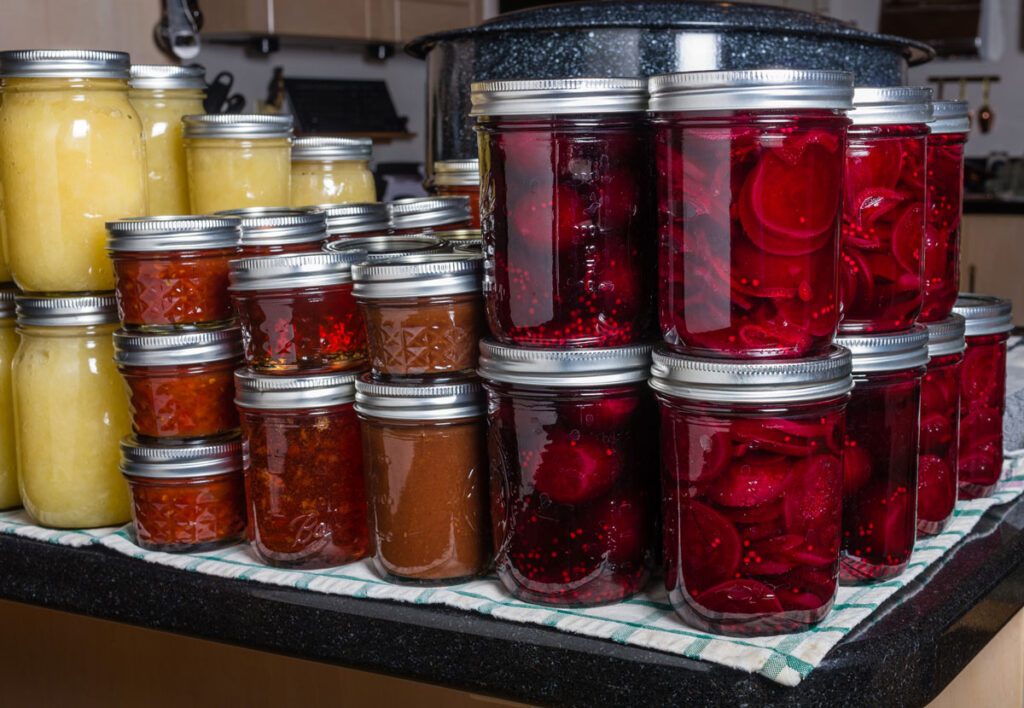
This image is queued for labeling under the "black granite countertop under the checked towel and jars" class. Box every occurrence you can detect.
[0,497,1024,706]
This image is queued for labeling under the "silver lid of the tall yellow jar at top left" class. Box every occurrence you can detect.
[0,49,131,79]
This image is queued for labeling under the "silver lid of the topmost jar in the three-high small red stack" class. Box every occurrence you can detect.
[106,216,242,253]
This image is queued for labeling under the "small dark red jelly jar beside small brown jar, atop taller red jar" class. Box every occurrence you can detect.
[230,250,367,374]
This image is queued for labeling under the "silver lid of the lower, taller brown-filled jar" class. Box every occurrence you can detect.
[355,373,487,421]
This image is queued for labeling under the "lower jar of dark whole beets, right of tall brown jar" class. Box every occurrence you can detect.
[479,340,657,607]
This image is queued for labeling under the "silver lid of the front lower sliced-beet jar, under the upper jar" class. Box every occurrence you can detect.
[650,344,853,404]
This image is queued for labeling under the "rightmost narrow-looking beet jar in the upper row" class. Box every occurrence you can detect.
[919,100,971,322]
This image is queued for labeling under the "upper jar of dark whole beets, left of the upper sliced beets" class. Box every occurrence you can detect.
[472,79,654,348]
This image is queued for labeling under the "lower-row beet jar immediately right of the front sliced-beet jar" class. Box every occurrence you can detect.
[837,325,928,585]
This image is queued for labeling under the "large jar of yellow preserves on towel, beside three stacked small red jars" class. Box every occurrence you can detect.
[12,295,131,529]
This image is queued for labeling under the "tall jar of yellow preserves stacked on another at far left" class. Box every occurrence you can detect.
[0,49,146,293]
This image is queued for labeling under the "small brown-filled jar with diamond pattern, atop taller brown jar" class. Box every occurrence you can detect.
[352,253,485,376]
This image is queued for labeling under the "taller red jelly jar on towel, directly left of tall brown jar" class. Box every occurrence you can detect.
[234,369,369,569]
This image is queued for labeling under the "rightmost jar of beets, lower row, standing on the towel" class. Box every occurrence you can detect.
[953,293,1013,499]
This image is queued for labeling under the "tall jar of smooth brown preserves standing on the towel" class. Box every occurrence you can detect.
[355,374,490,585]
